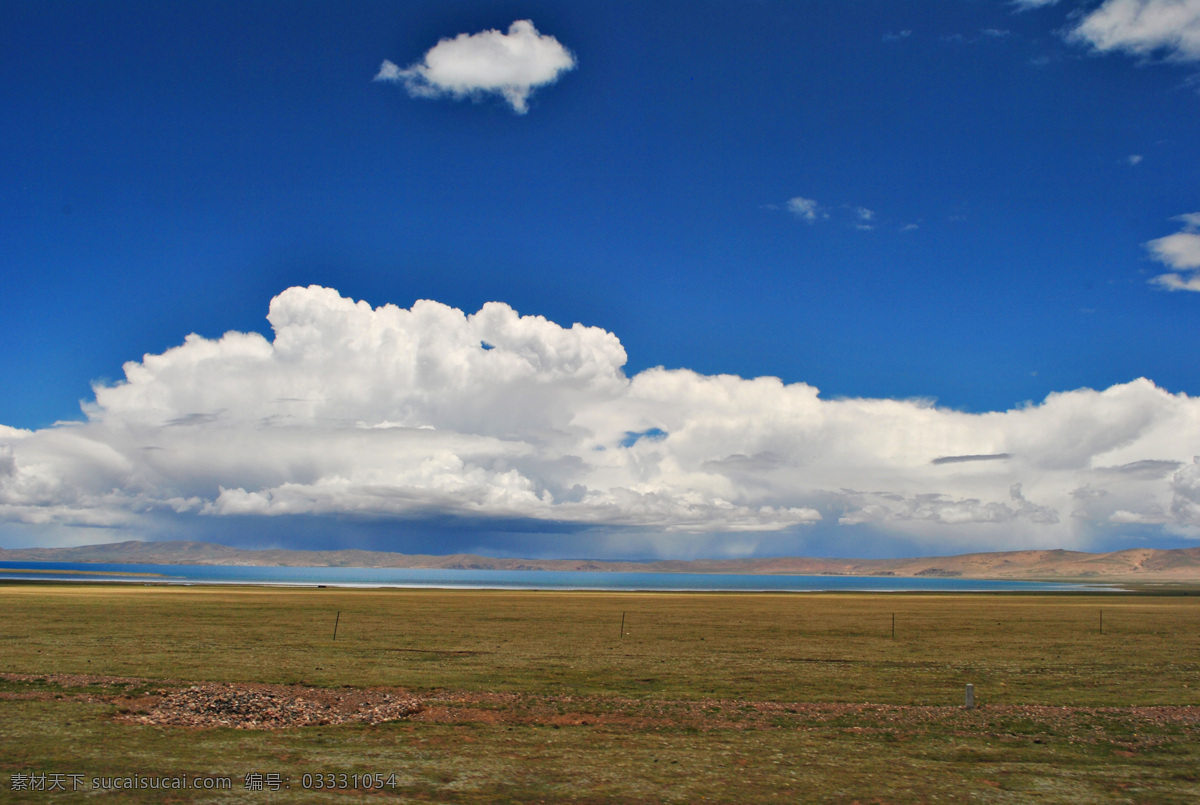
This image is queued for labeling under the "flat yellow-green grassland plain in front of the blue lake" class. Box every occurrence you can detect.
[0,582,1200,803]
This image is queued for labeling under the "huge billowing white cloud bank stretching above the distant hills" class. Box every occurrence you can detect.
[0,287,1200,552]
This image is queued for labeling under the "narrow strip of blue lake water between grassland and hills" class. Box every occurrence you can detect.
[0,561,1115,593]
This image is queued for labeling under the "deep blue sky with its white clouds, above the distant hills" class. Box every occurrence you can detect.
[0,0,1200,555]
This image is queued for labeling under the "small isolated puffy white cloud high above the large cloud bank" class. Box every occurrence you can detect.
[374,19,576,114]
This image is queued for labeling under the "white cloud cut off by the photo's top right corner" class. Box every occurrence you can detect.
[1068,0,1200,61]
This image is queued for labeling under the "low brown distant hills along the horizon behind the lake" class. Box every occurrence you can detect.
[0,541,1200,582]
